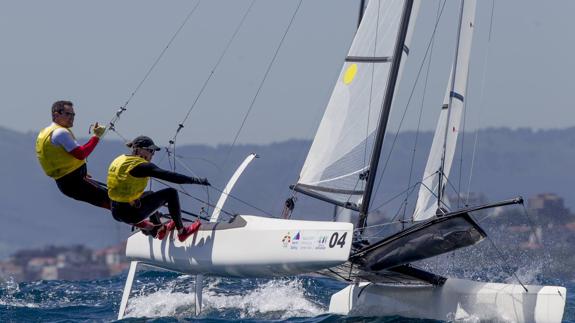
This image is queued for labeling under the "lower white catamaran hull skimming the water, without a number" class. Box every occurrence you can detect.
[329,279,566,322]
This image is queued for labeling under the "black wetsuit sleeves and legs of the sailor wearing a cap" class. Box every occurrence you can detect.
[112,163,203,229]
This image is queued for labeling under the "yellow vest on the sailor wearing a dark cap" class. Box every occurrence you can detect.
[108,155,149,202]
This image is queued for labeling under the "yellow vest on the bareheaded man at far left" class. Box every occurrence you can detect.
[36,124,86,179]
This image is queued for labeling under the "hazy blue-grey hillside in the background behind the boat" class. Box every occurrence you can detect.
[0,128,575,258]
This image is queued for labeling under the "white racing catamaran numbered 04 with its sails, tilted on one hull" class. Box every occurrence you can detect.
[118,0,566,322]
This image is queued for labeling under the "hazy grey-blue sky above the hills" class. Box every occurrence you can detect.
[0,0,575,145]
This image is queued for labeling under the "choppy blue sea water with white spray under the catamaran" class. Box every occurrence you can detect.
[0,271,575,322]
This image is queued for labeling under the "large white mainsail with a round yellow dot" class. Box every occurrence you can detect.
[297,0,419,208]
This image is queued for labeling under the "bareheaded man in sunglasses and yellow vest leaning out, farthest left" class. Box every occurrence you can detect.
[36,101,110,209]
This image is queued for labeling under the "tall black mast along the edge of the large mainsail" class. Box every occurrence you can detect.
[358,0,413,232]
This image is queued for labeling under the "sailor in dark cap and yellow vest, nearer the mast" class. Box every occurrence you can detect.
[108,136,210,242]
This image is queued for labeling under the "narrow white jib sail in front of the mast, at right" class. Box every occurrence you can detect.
[413,0,476,221]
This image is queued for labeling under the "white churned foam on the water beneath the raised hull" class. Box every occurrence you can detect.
[126,279,327,319]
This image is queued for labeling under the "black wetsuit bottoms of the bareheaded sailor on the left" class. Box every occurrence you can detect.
[56,164,110,209]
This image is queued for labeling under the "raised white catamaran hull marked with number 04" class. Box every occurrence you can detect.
[126,216,353,277]
